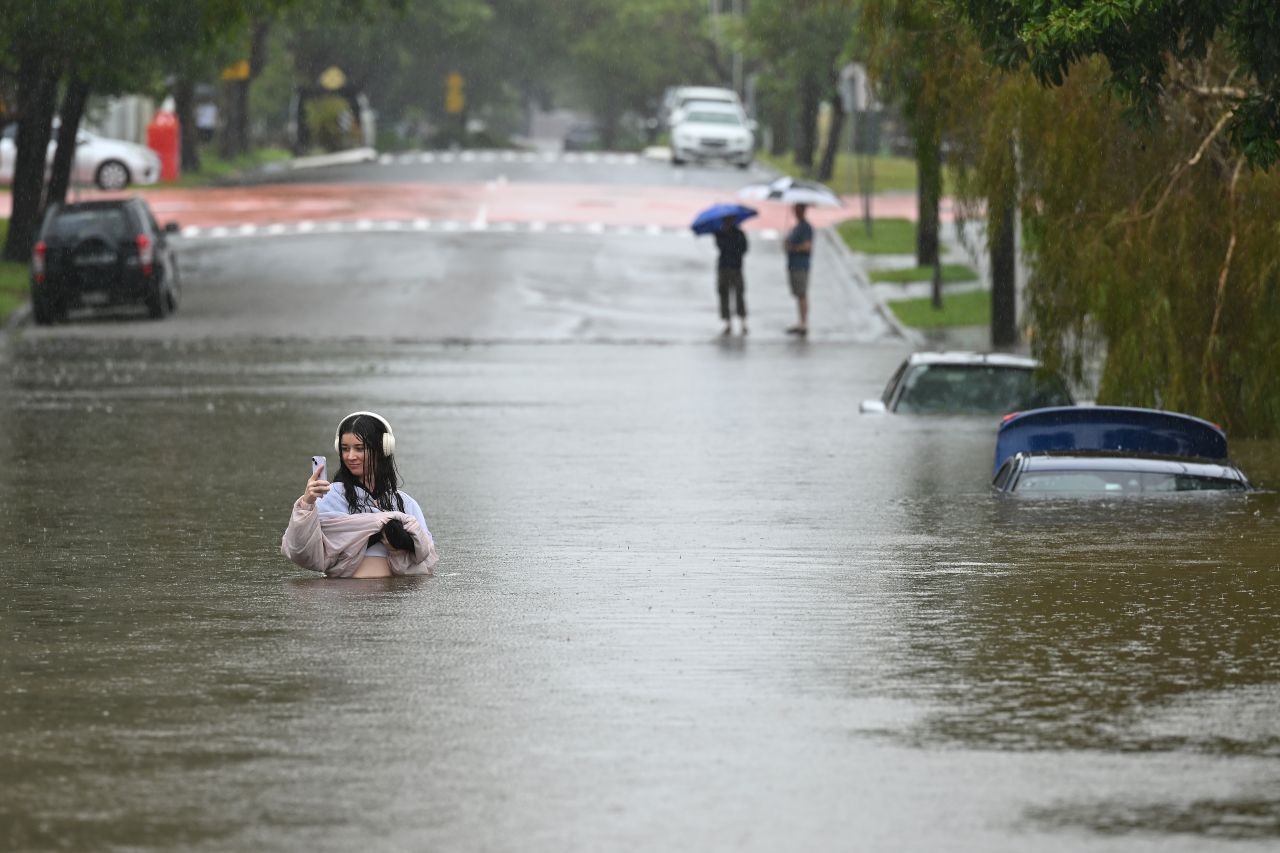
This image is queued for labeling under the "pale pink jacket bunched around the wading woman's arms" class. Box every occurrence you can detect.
[280,498,440,578]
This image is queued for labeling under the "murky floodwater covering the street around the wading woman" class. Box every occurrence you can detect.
[0,338,1280,850]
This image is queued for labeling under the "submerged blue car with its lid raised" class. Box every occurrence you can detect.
[992,406,1253,496]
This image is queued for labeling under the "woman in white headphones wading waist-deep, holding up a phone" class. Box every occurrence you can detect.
[280,411,439,578]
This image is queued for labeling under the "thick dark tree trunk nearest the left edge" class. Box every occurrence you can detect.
[4,54,58,264]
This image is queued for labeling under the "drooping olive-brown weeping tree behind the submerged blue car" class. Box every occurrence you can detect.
[942,3,1280,435]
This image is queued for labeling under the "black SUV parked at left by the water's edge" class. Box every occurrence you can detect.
[31,196,179,325]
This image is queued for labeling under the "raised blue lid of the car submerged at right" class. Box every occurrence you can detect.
[992,406,1226,474]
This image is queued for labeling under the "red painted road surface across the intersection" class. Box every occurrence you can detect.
[0,182,950,229]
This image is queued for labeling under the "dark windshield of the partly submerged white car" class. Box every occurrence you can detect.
[897,364,1071,415]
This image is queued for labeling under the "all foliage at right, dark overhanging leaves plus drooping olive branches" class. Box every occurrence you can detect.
[868,0,1280,437]
